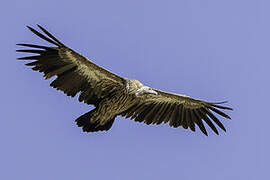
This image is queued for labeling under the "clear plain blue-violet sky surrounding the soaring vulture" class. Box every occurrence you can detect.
[0,0,270,180]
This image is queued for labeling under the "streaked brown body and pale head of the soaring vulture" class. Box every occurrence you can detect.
[77,79,155,131]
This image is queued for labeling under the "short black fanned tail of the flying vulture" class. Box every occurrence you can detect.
[75,110,115,132]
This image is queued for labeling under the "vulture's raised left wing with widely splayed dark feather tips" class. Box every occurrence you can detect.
[17,25,124,106]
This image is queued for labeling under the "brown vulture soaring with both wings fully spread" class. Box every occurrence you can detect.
[17,25,232,135]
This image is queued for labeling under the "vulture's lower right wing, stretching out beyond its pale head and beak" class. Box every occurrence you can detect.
[121,90,232,135]
